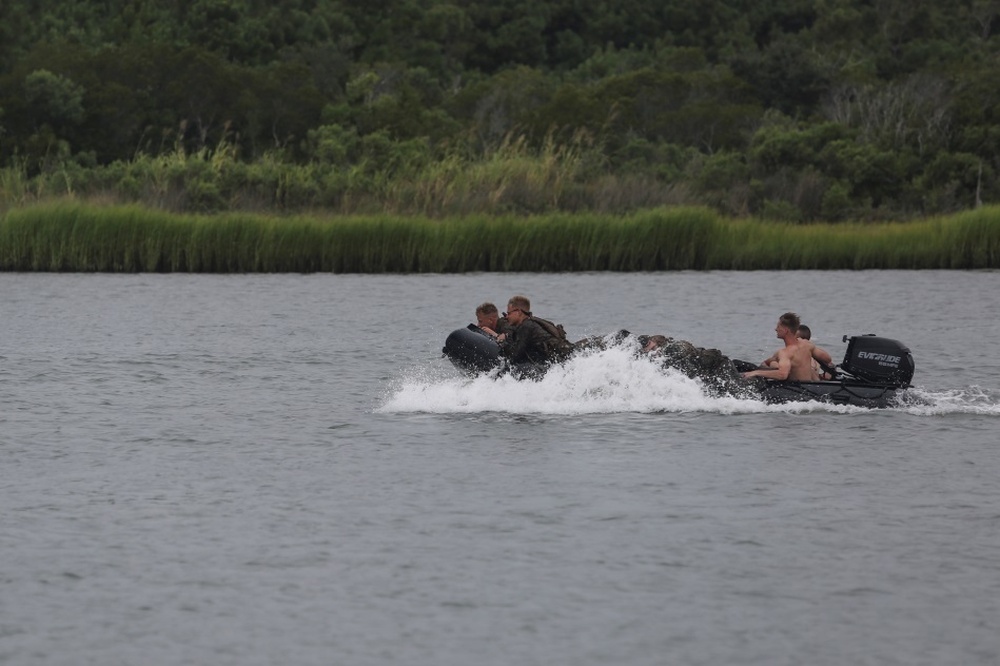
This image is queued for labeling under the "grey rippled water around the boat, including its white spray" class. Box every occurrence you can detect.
[0,272,1000,666]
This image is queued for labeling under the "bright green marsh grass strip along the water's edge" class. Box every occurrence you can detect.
[0,201,1000,273]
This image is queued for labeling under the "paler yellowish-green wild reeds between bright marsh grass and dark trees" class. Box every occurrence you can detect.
[0,135,693,218]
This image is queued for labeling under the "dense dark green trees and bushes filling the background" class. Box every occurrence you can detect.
[0,0,1000,220]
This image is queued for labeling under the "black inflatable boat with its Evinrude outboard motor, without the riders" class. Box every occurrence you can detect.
[441,324,915,408]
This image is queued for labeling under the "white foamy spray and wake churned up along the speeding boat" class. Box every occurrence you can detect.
[375,347,1000,416]
